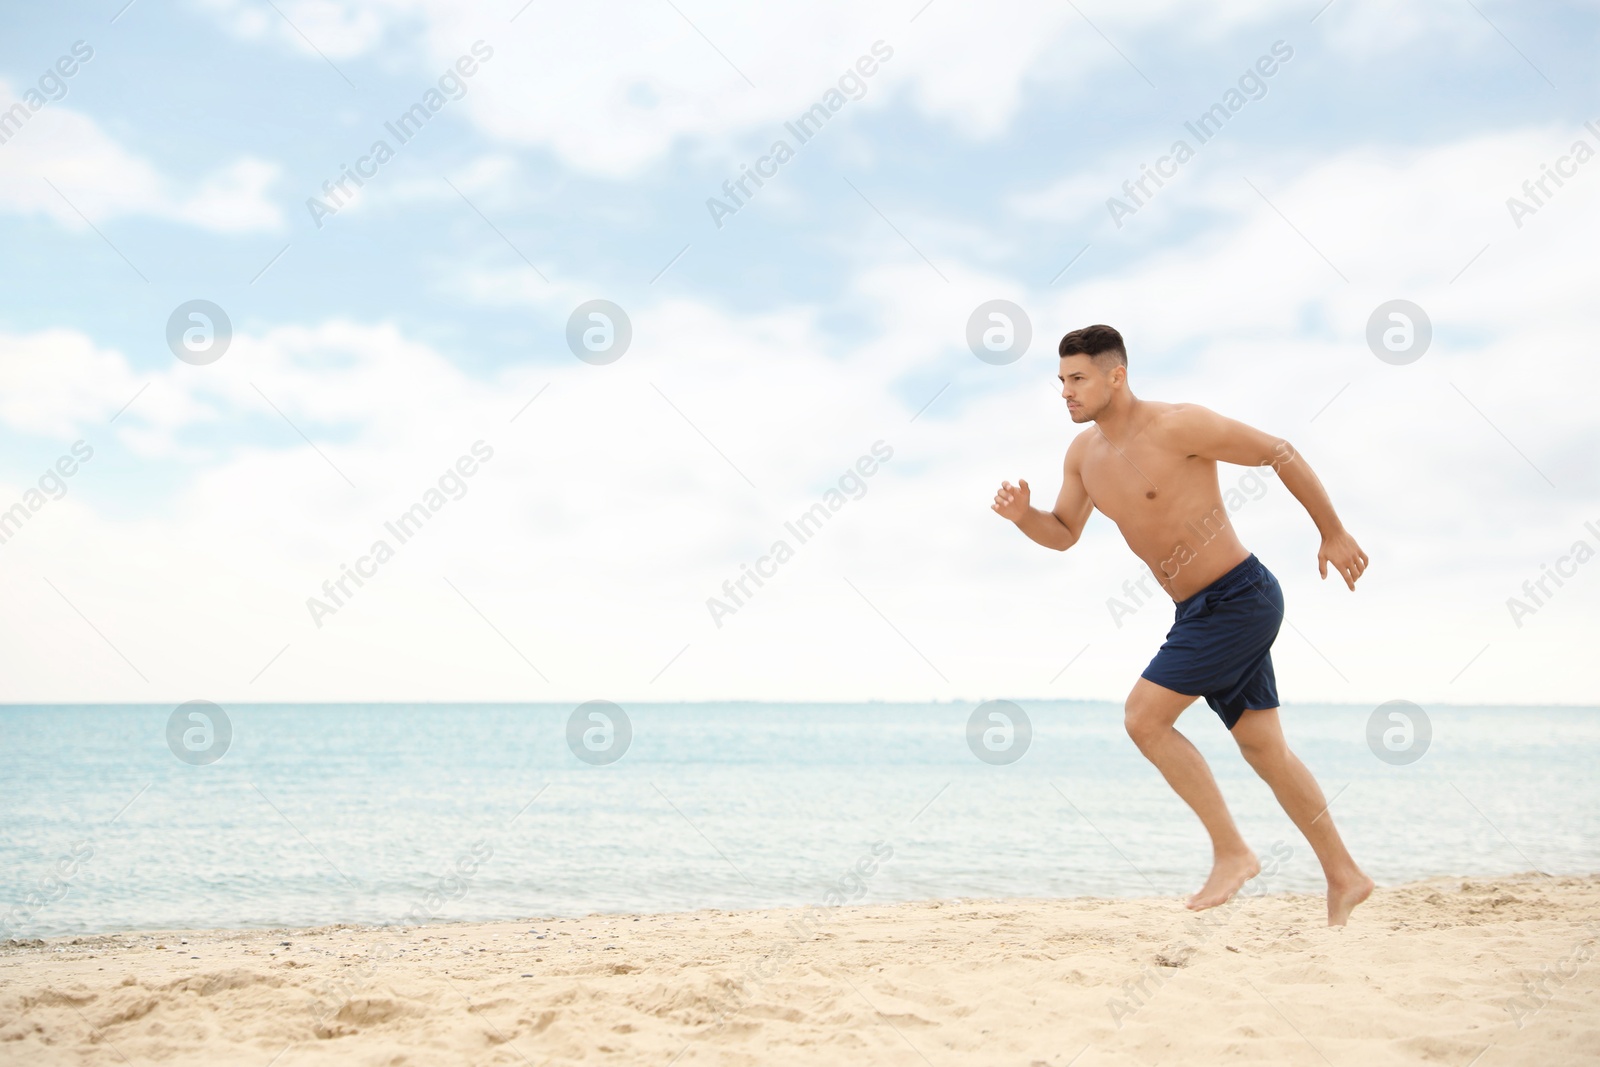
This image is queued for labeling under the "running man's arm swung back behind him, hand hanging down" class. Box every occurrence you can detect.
[1168,403,1366,590]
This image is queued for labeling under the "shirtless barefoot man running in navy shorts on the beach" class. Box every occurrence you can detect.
[994,326,1373,926]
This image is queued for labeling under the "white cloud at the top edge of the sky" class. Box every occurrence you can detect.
[190,0,1363,176]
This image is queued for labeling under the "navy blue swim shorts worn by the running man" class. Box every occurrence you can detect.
[1142,553,1283,729]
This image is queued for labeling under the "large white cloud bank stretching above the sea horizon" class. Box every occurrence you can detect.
[0,120,1600,702]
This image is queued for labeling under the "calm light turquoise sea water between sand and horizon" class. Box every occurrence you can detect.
[0,702,1600,937]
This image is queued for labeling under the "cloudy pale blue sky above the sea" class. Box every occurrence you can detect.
[0,0,1600,705]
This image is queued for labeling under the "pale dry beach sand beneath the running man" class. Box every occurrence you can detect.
[0,875,1600,1067]
